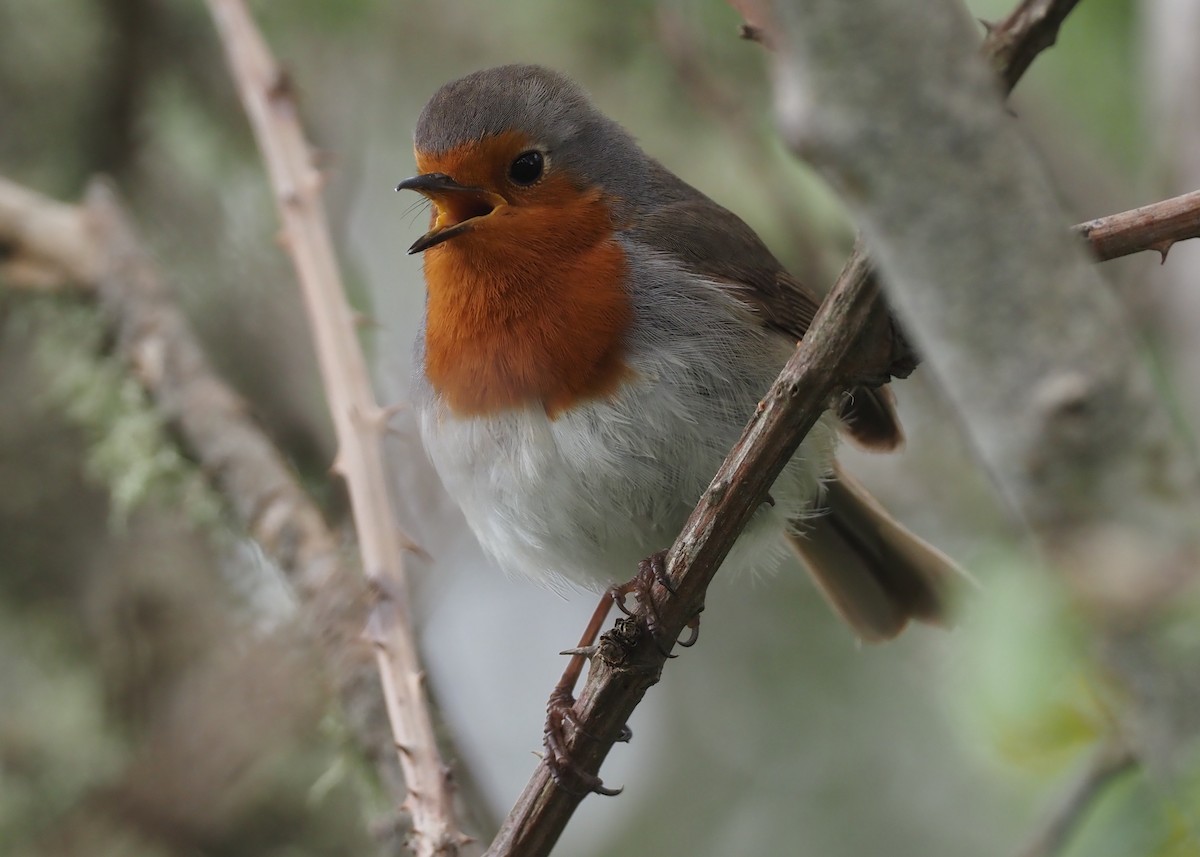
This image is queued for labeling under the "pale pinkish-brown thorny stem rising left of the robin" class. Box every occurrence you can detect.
[209,0,468,857]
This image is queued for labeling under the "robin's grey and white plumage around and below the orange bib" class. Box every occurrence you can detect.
[414,238,834,588]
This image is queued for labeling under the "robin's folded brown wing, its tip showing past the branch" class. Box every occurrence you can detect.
[629,177,904,450]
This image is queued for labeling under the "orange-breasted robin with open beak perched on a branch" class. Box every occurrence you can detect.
[396,65,958,791]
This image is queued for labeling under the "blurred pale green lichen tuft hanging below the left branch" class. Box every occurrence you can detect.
[26,300,222,528]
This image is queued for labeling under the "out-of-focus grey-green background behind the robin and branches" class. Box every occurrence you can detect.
[0,0,1200,857]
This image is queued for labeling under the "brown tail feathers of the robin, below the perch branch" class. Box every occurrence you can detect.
[790,469,962,642]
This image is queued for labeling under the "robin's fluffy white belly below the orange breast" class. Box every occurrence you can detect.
[418,336,834,589]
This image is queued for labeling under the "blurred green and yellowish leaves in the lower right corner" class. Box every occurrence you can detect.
[952,553,1200,857]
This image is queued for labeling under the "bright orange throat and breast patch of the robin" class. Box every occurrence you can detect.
[425,176,632,416]
